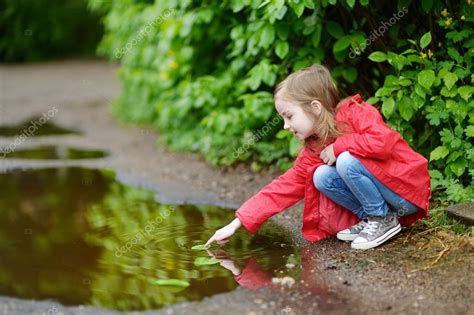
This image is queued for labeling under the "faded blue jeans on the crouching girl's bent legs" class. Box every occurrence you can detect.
[313,151,420,219]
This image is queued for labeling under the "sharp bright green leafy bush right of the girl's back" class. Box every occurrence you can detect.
[369,5,474,202]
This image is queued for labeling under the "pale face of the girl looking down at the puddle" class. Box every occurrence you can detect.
[275,95,314,140]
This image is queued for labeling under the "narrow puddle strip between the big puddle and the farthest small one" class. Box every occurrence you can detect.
[0,145,107,160]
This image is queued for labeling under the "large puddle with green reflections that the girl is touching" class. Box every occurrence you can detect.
[0,168,300,311]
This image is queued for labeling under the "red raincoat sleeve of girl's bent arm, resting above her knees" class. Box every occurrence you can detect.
[333,102,400,160]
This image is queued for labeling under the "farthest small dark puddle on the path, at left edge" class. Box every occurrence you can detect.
[0,117,79,137]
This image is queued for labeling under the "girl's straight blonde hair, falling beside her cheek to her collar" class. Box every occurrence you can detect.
[273,65,343,151]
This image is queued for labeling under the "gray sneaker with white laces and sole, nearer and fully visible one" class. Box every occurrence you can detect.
[351,211,402,249]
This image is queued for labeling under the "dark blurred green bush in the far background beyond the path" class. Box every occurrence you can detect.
[0,0,103,62]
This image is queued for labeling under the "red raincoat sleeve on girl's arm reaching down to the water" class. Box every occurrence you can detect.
[235,148,310,234]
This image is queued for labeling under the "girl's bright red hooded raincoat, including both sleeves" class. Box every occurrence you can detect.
[235,94,431,242]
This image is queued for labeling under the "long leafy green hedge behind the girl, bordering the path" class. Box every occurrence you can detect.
[89,0,473,200]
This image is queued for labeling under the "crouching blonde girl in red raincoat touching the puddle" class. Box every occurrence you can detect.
[206,65,431,249]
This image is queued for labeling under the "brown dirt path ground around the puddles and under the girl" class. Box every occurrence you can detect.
[0,60,474,314]
